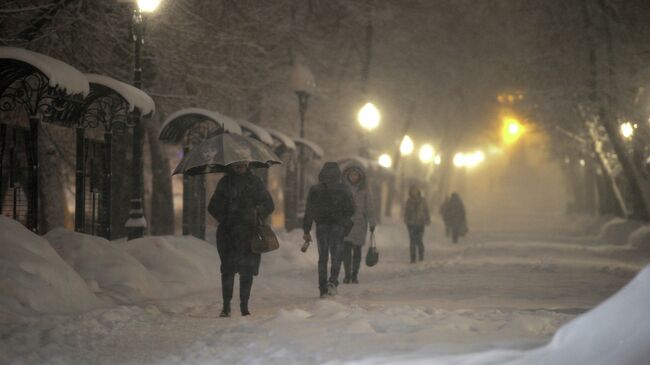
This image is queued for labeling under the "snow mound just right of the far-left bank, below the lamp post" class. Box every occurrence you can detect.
[45,228,165,304]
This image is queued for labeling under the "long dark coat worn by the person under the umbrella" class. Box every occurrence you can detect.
[208,171,275,275]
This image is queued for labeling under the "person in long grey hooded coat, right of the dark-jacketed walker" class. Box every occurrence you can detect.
[343,165,377,284]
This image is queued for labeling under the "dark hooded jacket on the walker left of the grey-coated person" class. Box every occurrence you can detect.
[303,162,354,233]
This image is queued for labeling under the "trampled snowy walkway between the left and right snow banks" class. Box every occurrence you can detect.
[0,219,648,364]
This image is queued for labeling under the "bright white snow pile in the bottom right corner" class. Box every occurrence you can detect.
[349,265,650,365]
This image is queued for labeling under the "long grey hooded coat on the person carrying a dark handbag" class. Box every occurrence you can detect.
[343,166,377,246]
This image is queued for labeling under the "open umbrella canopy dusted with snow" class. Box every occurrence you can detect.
[172,133,281,175]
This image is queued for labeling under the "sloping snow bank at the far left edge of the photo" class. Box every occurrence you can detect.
[0,216,102,314]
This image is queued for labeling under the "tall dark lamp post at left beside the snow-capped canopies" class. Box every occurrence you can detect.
[125,0,160,240]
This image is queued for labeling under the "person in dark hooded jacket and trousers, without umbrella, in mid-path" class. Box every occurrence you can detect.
[303,162,354,298]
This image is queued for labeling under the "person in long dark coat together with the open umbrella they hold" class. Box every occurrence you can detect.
[174,133,280,317]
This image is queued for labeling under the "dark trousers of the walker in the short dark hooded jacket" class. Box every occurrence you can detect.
[316,224,344,294]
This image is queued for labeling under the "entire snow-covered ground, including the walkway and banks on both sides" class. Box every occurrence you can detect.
[0,217,650,365]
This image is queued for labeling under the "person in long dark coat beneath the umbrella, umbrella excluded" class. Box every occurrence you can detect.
[208,162,275,317]
